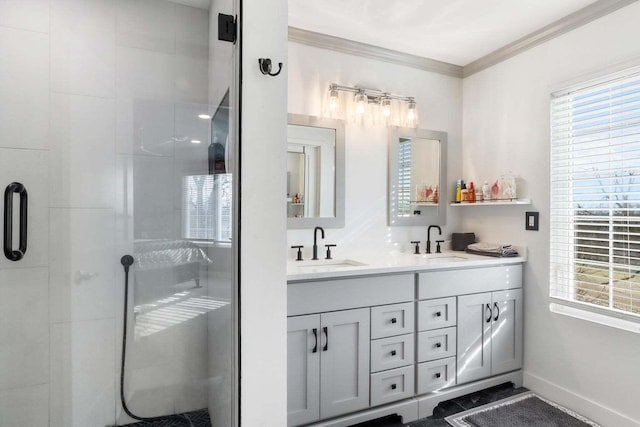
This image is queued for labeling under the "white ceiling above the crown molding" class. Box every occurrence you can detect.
[289,0,596,66]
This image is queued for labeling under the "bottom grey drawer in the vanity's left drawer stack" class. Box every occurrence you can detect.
[371,365,415,406]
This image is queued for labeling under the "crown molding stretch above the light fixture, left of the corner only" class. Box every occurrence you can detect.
[289,27,462,78]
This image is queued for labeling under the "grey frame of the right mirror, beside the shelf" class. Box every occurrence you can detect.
[387,127,449,226]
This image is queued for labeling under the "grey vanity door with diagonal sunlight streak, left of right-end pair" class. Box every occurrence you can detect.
[456,292,492,384]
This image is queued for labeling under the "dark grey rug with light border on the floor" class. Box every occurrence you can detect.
[445,392,600,427]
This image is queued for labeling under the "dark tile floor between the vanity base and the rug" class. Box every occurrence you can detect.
[357,383,529,427]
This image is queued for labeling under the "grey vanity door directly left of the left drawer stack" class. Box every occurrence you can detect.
[320,308,370,418]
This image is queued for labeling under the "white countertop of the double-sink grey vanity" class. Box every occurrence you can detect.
[287,248,526,282]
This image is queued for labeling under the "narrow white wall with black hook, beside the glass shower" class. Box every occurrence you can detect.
[240,0,289,427]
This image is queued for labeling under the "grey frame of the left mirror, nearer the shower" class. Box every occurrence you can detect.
[287,113,345,230]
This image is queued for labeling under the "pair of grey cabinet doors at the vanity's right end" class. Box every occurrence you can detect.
[457,289,522,384]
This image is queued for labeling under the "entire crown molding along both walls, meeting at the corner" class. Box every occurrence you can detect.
[289,0,638,78]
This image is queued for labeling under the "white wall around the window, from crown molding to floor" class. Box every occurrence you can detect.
[462,3,640,427]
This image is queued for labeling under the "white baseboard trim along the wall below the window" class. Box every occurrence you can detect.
[523,372,640,427]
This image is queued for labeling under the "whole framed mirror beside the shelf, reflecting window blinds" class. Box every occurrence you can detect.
[388,128,447,226]
